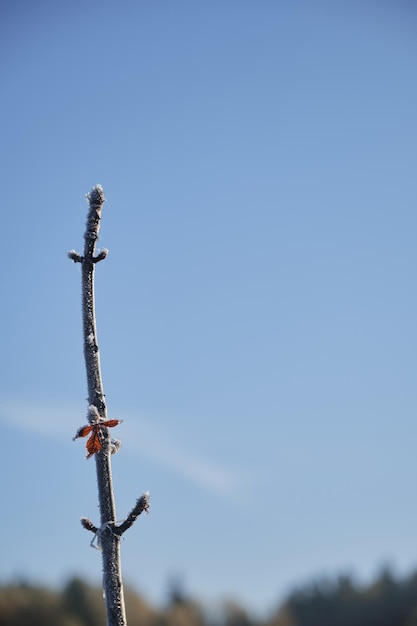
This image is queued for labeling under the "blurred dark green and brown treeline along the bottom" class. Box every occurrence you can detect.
[0,570,417,626]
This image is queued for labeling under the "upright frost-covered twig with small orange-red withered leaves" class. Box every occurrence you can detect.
[68,185,149,626]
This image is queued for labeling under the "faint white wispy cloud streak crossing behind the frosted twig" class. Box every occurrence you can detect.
[0,400,242,495]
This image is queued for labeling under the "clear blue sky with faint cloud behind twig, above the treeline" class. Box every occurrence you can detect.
[0,0,417,611]
